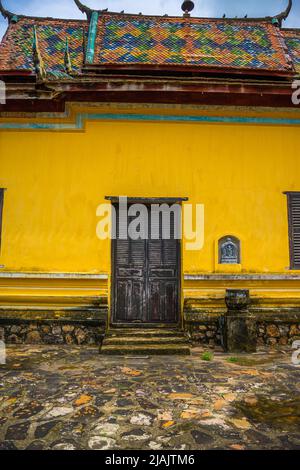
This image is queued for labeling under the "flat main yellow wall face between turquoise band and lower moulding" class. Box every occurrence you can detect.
[0,109,300,273]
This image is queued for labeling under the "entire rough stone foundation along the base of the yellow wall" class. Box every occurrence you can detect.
[0,310,300,348]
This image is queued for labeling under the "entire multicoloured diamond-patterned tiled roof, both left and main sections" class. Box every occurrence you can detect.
[0,13,300,79]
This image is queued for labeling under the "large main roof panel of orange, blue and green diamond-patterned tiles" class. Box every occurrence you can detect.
[94,15,291,71]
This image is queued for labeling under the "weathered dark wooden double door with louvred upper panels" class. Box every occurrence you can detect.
[112,205,181,323]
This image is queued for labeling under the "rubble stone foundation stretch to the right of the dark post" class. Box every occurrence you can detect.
[257,322,300,347]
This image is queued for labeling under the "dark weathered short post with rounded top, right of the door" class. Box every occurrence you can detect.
[224,289,257,353]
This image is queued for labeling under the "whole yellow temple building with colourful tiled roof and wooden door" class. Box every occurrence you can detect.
[0,0,300,354]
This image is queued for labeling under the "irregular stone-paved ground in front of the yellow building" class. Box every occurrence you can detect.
[0,345,300,450]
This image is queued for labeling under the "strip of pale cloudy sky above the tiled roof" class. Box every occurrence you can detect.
[0,0,300,38]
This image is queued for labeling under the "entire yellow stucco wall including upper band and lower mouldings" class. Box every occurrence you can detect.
[0,104,300,311]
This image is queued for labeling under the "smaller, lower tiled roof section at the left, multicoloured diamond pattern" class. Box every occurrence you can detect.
[0,18,87,78]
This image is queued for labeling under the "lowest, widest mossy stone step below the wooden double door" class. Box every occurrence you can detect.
[100,344,190,356]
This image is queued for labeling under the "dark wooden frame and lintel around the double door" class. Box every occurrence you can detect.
[105,196,188,328]
